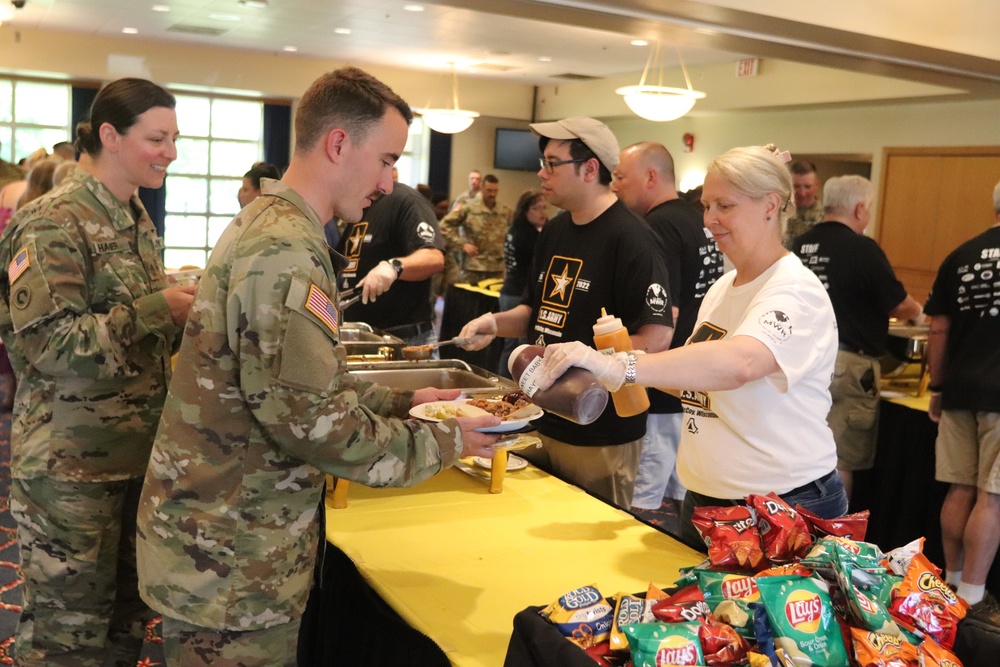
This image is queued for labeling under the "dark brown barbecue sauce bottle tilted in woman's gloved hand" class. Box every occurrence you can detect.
[507,345,608,426]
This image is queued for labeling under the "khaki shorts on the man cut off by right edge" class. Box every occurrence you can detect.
[934,410,1000,493]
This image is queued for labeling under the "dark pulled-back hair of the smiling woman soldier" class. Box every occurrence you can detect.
[74,78,177,157]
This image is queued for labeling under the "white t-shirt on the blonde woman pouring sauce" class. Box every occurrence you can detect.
[677,254,837,499]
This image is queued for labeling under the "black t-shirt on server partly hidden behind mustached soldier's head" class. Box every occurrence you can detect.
[337,183,444,329]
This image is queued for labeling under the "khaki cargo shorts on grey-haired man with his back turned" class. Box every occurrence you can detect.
[826,350,880,470]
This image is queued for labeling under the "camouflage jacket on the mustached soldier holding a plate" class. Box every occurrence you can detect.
[138,181,462,630]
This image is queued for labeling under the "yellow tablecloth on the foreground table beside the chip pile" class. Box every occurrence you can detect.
[327,466,702,667]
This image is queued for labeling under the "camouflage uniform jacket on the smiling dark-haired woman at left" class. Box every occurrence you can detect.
[0,169,180,482]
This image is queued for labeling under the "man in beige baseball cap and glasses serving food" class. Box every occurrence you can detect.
[461,117,673,509]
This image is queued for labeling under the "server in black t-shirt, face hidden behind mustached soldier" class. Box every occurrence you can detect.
[337,183,444,345]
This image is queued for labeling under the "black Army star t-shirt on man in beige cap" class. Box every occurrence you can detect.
[522,201,673,445]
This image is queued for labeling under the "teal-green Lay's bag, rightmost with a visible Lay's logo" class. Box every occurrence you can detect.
[757,575,848,667]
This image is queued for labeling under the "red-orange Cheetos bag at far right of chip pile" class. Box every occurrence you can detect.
[890,553,968,649]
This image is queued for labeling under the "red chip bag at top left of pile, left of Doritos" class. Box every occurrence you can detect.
[691,505,766,572]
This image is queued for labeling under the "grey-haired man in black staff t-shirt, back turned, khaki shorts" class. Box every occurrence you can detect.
[793,176,921,498]
